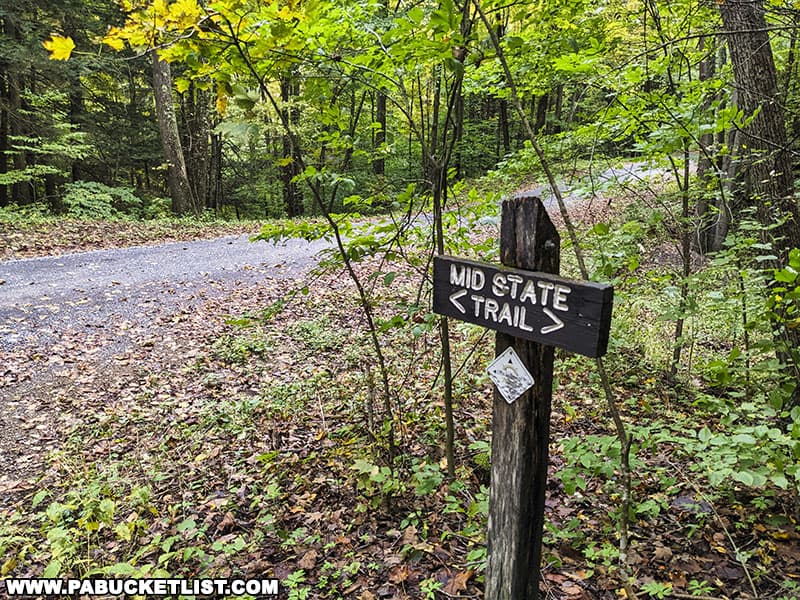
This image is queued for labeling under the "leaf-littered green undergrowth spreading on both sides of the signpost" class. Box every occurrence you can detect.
[0,186,800,600]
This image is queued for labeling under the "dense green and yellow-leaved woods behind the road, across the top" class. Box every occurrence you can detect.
[0,1,797,232]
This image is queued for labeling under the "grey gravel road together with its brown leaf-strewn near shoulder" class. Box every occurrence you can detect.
[0,236,325,496]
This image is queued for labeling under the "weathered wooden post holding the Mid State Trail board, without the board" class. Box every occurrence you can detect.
[486,196,560,600]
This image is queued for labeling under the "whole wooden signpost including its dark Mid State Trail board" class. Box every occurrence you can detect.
[433,196,614,600]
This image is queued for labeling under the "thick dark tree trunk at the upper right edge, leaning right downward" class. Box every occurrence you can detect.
[718,0,800,253]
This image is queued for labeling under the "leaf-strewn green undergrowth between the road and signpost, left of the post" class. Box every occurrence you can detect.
[0,270,494,598]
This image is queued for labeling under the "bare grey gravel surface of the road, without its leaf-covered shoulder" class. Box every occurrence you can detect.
[0,236,326,351]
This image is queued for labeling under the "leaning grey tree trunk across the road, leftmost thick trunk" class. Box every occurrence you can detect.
[152,50,197,215]
